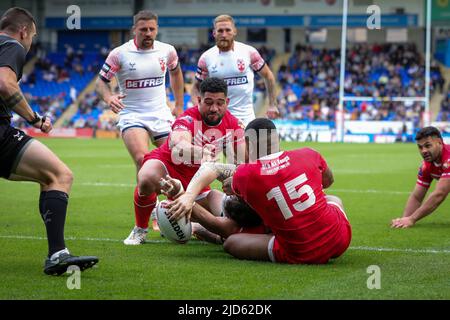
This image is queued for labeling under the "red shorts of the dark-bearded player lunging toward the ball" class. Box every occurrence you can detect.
[142,148,211,200]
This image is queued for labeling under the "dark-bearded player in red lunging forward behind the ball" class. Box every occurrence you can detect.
[130,78,244,244]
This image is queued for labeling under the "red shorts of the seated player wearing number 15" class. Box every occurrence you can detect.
[268,202,352,264]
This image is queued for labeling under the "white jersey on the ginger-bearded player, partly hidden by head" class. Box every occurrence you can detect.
[195,41,265,120]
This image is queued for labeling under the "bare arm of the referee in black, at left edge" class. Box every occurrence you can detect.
[0,67,52,133]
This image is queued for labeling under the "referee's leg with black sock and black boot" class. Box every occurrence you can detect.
[8,140,98,275]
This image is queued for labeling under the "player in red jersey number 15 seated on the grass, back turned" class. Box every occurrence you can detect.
[169,118,351,264]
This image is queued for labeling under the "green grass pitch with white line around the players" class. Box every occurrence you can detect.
[0,139,450,300]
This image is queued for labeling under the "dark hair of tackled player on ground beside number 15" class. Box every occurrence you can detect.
[224,196,262,228]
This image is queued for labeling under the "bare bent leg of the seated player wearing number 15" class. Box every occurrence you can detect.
[223,233,273,261]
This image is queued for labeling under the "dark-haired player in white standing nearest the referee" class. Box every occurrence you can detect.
[96,10,184,245]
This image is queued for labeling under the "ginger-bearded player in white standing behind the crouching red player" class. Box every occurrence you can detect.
[192,15,279,125]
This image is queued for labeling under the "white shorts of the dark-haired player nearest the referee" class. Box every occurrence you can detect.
[117,108,174,141]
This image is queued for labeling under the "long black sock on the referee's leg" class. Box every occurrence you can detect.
[39,190,69,257]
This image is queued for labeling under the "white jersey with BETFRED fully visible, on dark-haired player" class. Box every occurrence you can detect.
[100,39,178,113]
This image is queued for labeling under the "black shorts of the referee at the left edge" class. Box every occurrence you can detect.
[0,118,33,179]
